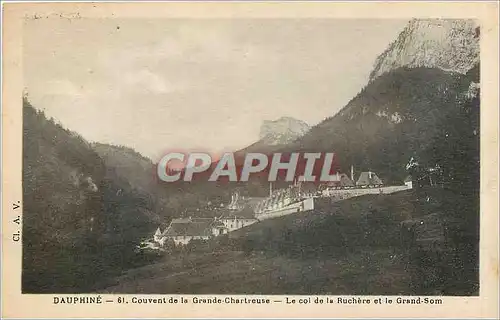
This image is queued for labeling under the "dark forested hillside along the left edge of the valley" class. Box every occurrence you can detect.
[23,99,160,292]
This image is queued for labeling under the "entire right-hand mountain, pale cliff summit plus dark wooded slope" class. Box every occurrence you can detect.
[280,19,480,183]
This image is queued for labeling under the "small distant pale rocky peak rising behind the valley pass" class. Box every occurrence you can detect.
[259,117,310,145]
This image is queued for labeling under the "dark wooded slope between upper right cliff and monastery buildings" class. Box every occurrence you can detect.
[283,68,473,183]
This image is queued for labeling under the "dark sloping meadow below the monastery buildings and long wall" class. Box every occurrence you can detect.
[100,193,412,294]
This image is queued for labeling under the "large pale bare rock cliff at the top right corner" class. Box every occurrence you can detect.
[370,19,479,81]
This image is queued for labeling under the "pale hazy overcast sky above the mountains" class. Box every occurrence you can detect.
[24,18,407,160]
